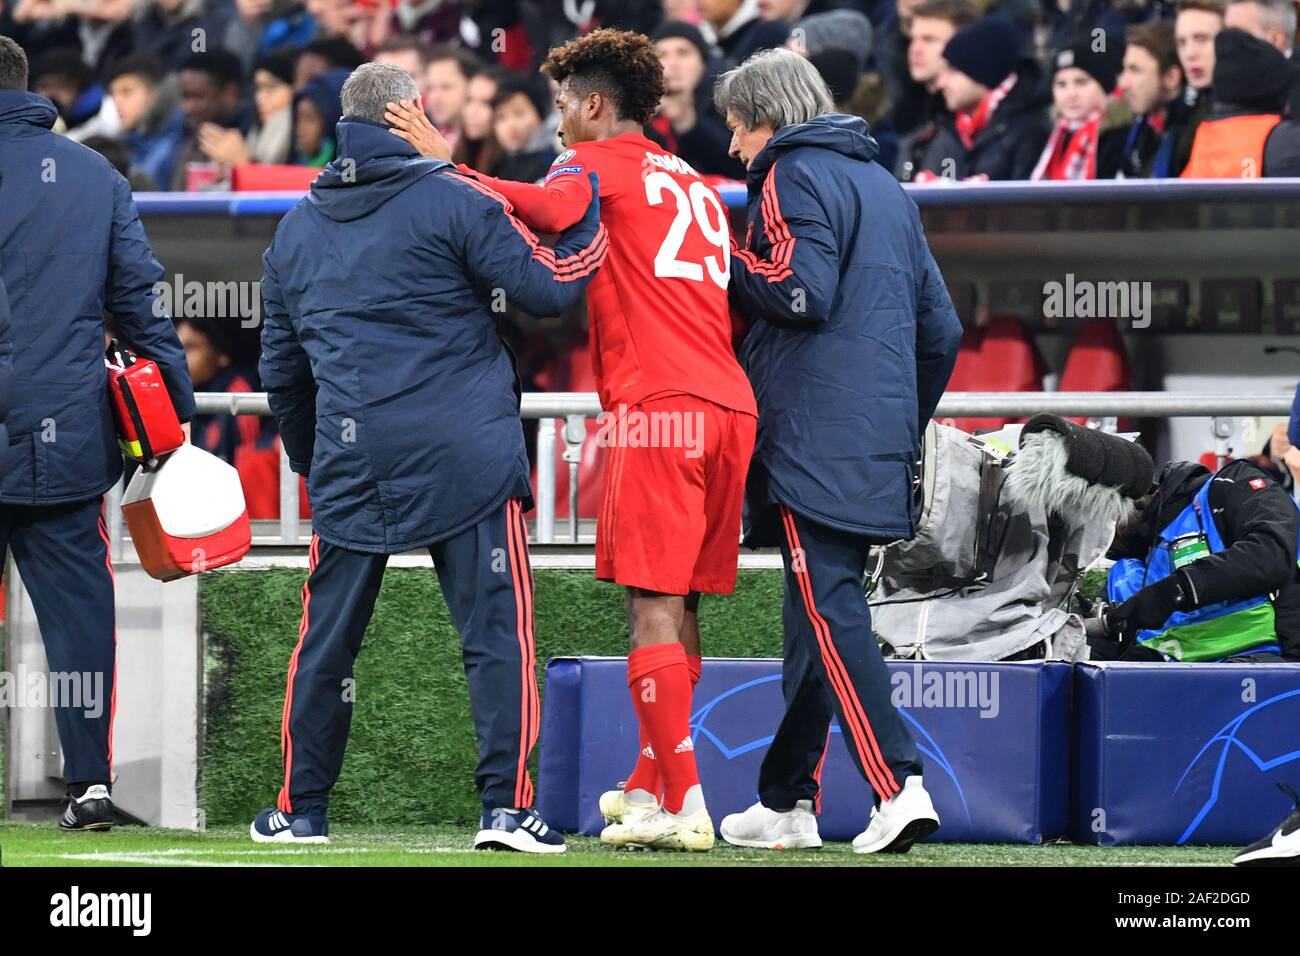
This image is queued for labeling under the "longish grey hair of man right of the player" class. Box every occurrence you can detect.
[714,48,835,133]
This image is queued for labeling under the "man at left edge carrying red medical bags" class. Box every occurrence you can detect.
[0,36,194,830]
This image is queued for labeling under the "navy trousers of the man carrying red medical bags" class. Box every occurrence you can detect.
[0,498,117,784]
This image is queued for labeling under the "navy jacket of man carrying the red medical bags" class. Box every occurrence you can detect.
[0,90,194,506]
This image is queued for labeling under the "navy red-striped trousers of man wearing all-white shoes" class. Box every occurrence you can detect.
[758,506,920,810]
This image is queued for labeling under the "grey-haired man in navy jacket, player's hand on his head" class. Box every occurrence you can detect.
[252,64,606,852]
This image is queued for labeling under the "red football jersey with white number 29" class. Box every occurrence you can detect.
[480,133,758,415]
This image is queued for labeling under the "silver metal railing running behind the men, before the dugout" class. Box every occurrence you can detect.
[98,392,1292,558]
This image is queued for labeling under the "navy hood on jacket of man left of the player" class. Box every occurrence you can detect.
[308,117,450,222]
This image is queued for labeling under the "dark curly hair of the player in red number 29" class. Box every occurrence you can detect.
[542,29,666,124]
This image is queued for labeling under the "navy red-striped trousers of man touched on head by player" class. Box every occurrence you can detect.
[278,498,541,813]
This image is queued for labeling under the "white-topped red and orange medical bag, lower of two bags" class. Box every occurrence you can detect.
[122,445,252,581]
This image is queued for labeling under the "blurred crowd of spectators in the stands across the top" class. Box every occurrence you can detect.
[0,0,1300,190]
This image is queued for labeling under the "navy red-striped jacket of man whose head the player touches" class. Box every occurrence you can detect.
[266,118,606,553]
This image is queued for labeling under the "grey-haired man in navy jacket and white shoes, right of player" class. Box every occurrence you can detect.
[716,49,961,853]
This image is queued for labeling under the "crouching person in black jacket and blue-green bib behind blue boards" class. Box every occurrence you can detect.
[1088,460,1300,662]
